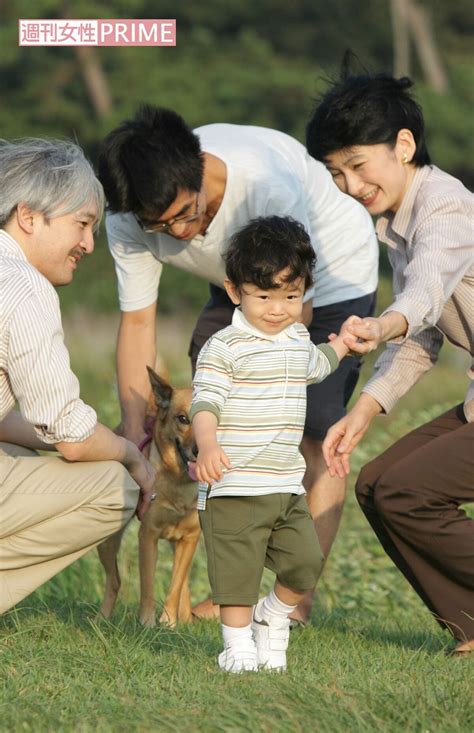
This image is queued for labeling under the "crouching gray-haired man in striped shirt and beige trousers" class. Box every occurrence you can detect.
[0,140,154,613]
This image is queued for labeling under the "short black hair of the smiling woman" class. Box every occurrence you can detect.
[306,74,431,167]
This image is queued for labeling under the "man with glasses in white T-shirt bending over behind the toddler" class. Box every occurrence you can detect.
[99,105,378,621]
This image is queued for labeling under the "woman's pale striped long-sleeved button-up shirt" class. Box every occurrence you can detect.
[363,166,474,422]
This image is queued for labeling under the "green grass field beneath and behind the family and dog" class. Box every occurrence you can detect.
[0,313,474,733]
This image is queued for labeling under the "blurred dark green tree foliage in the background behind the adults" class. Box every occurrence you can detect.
[0,0,473,182]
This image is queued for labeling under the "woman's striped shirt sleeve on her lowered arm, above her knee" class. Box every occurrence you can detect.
[362,328,443,412]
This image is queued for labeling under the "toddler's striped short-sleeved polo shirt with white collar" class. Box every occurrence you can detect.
[191,309,339,509]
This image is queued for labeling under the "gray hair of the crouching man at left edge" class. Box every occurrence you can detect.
[0,138,104,227]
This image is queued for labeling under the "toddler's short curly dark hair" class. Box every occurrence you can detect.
[225,216,316,290]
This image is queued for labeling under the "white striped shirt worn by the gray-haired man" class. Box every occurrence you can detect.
[0,230,97,444]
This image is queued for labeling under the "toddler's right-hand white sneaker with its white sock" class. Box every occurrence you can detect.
[252,598,290,672]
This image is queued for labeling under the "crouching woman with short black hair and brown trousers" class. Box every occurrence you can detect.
[307,75,474,654]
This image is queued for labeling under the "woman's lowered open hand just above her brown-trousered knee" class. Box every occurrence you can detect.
[323,394,382,478]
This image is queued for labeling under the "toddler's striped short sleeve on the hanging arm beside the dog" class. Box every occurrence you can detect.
[190,338,235,420]
